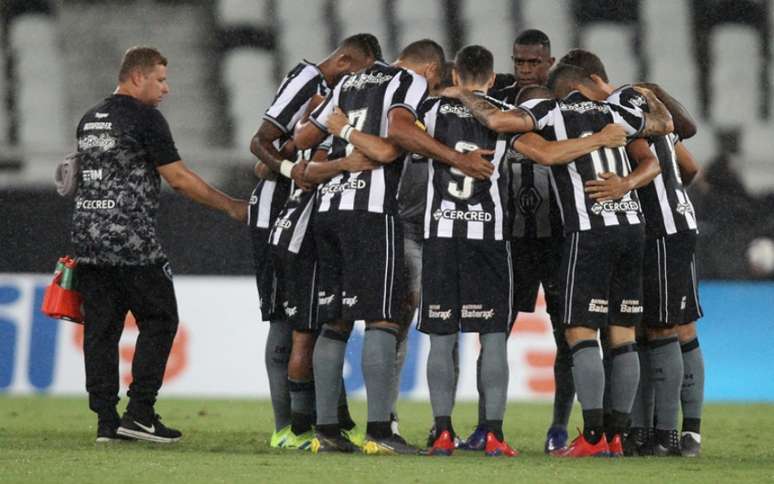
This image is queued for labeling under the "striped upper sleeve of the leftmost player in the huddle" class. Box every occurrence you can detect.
[263,66,322,135]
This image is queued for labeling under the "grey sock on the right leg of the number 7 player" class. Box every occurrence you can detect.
[362,327,397,422]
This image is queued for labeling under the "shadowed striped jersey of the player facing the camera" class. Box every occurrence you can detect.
[490,84,562,239]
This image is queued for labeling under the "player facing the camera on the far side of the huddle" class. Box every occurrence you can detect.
[492,29,575,453]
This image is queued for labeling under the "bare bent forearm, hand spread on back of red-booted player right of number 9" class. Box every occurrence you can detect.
[585,139,661,202]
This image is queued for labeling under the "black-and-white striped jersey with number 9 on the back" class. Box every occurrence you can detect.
[424,93,508,240]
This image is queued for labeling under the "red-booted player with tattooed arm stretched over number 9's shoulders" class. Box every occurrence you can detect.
[446,61,672,457]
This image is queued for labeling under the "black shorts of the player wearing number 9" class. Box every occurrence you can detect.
[417,238,513,334]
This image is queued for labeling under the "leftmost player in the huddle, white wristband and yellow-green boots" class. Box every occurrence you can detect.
[249,34,375,447]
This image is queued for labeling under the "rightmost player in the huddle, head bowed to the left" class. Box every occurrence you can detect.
[562,49,703,456]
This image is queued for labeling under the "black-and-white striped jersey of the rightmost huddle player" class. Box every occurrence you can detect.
[608,86,698,238]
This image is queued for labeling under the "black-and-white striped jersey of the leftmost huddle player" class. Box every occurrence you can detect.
[247,61,329,229]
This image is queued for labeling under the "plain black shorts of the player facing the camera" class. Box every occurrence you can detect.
[511,237,562,321]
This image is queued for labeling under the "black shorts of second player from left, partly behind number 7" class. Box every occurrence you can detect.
[272,237,318,332]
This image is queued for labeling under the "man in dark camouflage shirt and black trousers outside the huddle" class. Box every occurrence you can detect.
[72,47,247,442]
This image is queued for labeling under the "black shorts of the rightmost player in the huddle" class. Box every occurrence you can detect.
[642,231,702,328]
